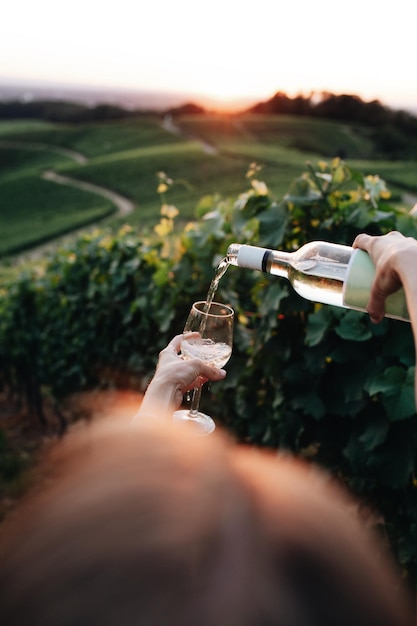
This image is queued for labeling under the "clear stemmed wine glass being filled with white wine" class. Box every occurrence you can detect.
[173,301,234,435]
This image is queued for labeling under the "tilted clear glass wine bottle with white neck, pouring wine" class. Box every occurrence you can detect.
[226,241,410,322]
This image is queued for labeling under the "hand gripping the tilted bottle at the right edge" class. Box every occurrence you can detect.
[353,231,417,327]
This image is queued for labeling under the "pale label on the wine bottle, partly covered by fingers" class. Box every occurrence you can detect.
[343,249,410,322]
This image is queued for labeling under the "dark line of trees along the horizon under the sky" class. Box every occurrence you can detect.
[0,91,417,160]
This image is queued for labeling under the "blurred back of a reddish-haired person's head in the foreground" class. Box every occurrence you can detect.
[0,414,412,626]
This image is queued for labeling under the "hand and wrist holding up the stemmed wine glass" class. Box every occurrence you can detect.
[134,333,226,420]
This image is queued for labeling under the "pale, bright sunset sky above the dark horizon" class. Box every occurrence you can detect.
[0,0,417,111]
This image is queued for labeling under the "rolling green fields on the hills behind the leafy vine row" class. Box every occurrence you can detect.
[0,115,417,259]
